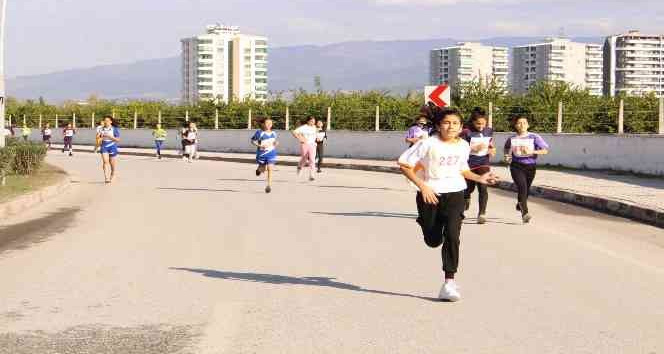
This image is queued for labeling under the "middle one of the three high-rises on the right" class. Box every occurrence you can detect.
[511,38,602,95]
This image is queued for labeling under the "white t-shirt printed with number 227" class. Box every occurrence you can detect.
[399,136,470,194]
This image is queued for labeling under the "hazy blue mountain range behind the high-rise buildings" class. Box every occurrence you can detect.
[7,37,603,102]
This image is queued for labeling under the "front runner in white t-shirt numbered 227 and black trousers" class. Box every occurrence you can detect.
[399,109,497,301]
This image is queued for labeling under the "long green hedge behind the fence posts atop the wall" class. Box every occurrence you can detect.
[7,82,659,133]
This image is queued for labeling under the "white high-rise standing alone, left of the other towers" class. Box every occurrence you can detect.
[181,25,268,103]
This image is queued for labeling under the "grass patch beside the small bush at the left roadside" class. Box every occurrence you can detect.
[0,163,66,203]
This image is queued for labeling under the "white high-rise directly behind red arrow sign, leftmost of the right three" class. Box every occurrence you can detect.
[429,42,508,87]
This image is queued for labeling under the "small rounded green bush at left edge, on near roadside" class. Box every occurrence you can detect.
[0,139,47,176]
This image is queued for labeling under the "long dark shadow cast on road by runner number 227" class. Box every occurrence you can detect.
[170,268,440,302]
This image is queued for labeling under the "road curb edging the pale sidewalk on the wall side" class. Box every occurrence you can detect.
[70,149,664,228]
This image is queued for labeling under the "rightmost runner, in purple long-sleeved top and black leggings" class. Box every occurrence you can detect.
[505,114,549,224]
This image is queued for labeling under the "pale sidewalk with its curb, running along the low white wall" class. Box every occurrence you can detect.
[61,145,664,228]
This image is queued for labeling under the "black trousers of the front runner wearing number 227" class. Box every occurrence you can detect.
[415,192,464,279]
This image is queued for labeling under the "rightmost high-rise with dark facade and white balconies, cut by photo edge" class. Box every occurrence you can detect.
[604,31,664,97]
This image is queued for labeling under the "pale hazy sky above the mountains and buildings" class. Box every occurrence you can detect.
[5,0,664,77]
